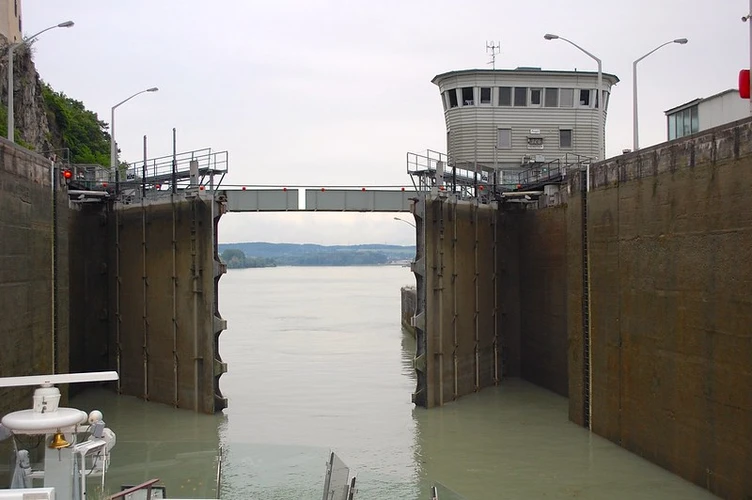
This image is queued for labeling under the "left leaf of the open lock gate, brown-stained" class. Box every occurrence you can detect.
[109,195,226,413]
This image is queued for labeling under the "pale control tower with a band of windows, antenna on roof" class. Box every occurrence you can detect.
[432,68,619,180]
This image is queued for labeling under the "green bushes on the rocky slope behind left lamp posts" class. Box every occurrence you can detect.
[42,83,110,166]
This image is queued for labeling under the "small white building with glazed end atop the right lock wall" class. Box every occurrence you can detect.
[665,89,750,141]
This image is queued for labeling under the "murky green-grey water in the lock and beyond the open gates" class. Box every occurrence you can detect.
[73,266,715,500]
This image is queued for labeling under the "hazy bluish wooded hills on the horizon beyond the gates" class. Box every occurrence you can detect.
[219,242,415,266]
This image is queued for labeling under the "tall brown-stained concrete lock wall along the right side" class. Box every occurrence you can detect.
[568,120,752,498]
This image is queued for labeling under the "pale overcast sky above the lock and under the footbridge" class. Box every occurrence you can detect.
[22,0,750,244]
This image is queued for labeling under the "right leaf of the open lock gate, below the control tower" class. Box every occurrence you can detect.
[413,197,502,408]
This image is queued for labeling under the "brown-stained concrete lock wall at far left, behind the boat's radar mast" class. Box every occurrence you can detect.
[0,139,68,415]
